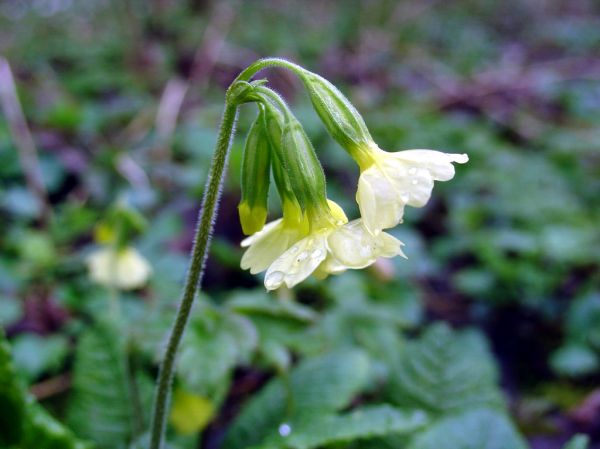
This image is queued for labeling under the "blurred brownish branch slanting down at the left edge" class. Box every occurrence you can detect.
[0,56,51,224]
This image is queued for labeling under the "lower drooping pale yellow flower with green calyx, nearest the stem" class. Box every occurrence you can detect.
[241,87,410,290]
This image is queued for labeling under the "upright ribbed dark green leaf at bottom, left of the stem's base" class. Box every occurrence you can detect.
[68,323,134,449]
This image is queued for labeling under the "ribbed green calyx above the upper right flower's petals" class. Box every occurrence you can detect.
[299,70,373,156]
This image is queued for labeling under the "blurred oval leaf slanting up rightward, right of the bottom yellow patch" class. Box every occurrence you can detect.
[223,351,369,449]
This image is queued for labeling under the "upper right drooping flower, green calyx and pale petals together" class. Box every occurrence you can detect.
[296,68,469,234]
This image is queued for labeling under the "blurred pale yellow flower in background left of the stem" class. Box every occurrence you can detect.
[86,247,152,290]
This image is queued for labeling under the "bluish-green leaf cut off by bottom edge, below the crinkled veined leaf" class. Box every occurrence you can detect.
[408,409,527,449]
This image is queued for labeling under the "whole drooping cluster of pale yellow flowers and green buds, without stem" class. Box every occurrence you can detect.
[229,67,468,290]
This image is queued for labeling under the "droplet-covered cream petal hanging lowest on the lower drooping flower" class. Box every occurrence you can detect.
[265,230,331,290]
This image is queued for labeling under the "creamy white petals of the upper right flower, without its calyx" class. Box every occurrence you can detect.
[356,144,469,234]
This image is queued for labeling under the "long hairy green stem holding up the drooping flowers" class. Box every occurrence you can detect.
[150,104,238,449]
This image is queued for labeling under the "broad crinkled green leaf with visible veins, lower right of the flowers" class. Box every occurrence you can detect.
[389,324,503,414]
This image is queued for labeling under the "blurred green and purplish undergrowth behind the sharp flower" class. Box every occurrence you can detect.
[0,0,600,449]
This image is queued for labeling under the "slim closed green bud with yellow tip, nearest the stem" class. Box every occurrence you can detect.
[238,109,271,235]
